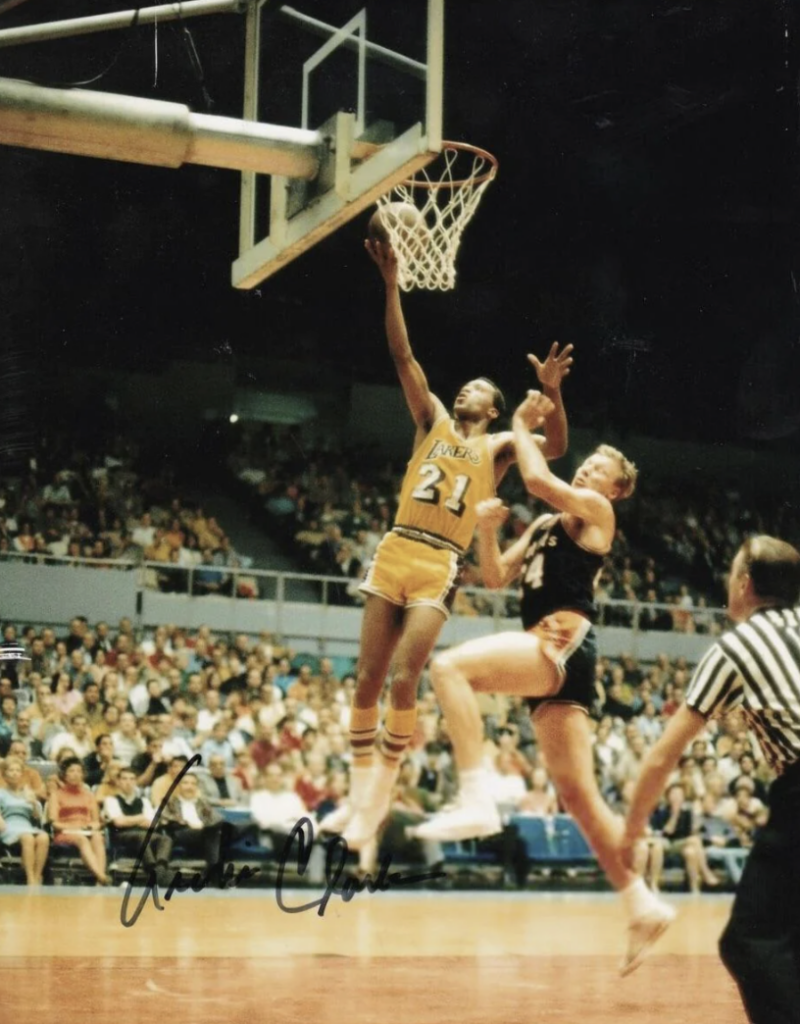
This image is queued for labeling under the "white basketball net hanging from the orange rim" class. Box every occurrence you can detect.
[378,142,497,292]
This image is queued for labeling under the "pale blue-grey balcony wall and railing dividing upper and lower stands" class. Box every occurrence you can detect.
[0,552,726,660]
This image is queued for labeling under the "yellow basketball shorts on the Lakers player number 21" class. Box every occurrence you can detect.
[359,532,464,618]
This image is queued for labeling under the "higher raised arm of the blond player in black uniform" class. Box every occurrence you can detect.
[511,391,614,534]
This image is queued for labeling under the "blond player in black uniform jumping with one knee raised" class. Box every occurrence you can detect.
[410,392,675,973]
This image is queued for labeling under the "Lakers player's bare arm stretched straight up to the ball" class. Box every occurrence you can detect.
[364,239,447,433]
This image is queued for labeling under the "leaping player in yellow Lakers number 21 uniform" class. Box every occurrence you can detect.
[322,240,573,849]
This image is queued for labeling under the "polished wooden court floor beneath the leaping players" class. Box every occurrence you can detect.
[0,887,746,1024]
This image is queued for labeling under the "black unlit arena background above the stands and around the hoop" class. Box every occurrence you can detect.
[0,0,800,456]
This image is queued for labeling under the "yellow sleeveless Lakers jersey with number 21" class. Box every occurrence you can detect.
[395,417,495,551]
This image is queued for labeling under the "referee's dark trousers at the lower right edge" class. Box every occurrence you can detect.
[719,765,800,1024]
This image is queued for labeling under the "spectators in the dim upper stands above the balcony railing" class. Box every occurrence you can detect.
[0,425,800,635]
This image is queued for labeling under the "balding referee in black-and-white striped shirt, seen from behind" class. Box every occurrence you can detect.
[622,537,800,1024]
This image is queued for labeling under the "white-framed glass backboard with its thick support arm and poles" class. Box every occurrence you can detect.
[0,0,445,288]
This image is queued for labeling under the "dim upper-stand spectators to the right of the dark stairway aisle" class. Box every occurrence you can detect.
[228,419,800,634]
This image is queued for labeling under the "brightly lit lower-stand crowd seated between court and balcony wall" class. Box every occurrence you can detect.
[0,616,770,889]
